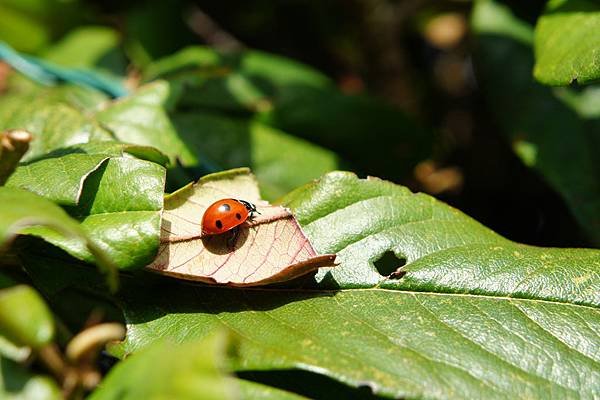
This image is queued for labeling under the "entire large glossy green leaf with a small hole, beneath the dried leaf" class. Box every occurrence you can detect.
[119,172,600,398]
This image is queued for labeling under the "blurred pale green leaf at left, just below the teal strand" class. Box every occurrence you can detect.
[0,75,195,165]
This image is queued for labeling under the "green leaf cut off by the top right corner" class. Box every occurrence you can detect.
[533,0,600,85]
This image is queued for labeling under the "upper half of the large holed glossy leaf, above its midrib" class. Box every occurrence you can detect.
[284,172,600,306]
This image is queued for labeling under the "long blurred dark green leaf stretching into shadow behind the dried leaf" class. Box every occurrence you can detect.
[145,47,430,178]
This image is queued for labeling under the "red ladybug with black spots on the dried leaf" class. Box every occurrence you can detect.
[202,199,260,235]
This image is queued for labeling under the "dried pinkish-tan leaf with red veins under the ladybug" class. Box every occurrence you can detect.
[148,168,335,286]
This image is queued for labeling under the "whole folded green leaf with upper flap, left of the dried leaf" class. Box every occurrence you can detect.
[7,142,166,269]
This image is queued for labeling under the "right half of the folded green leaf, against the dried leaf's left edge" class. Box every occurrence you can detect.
[20,158,165,269]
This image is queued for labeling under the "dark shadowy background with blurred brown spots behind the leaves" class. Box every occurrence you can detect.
[2,0,593,247]
